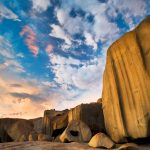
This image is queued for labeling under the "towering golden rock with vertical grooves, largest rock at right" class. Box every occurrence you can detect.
[102,16,150,143]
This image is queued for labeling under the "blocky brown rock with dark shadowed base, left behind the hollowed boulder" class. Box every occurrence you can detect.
[42,109,68,137]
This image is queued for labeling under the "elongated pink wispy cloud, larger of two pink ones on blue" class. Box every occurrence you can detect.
[20,25,39,56]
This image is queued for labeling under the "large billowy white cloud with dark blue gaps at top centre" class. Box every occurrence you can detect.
[50,0,119,50]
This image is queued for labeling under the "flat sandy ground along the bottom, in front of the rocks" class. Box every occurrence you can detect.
[0,142,150,150]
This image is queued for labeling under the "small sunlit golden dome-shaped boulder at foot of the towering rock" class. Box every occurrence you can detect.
[89,133,115,149]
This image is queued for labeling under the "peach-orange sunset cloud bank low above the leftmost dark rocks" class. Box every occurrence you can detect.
[0,76,55,118]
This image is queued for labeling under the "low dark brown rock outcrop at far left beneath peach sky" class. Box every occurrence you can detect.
[0,118,42,142]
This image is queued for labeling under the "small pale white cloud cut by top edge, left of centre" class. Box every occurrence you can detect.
[32,0,51,13]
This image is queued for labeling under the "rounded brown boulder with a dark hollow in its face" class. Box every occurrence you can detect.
[60,120,92,142]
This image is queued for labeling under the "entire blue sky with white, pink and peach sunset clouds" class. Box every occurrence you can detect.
[0,0,150,119]
